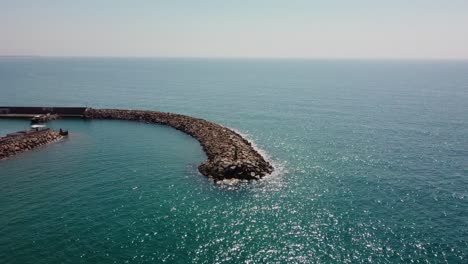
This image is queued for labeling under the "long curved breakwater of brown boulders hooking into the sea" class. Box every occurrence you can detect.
[84,108,273,181]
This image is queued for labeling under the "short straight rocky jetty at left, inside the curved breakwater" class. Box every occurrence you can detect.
[0,128,63,159]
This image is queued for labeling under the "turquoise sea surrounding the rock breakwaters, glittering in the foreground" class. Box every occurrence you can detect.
[0,58,468,263]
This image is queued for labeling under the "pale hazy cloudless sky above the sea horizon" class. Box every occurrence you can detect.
[0,0,468,59]
